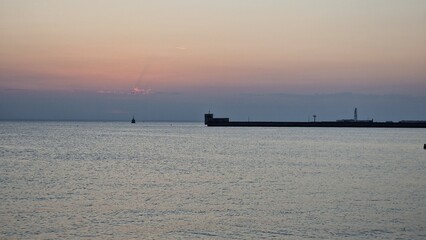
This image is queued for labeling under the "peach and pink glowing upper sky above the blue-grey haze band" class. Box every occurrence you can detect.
[0,0,426,94]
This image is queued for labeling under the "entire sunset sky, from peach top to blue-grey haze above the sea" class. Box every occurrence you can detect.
[0,0,426,121]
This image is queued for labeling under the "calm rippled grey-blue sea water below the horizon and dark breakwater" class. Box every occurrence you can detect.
[0,122,426,239]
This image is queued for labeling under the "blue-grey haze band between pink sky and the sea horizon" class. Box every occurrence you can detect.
[0,90,426,122]
